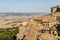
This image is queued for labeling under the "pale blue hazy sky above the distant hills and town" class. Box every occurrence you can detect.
[0,0,60,12]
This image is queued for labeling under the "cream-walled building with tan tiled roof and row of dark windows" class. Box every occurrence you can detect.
[42,18,58,27]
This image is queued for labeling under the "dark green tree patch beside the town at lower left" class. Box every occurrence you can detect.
[0,27,19,40]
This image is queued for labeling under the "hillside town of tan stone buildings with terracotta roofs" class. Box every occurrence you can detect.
[17,6,60,40]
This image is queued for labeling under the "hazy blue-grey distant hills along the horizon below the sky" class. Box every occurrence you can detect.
[0,12,47,16]
